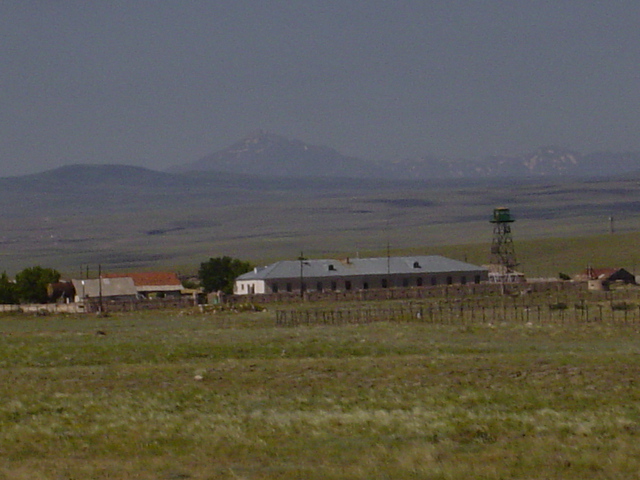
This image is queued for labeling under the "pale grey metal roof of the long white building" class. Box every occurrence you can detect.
[236,255,486,280]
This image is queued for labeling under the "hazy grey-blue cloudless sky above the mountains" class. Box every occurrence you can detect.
[0,0,640,176]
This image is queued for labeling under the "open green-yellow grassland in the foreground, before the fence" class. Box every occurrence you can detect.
[0,311,640,480]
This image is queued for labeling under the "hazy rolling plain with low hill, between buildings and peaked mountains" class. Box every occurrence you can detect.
[0,166,640,276]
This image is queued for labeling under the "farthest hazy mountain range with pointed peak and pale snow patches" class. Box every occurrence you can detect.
[171,131,640,180]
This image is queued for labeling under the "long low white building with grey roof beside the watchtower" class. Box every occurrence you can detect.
[234,255,488,295]
